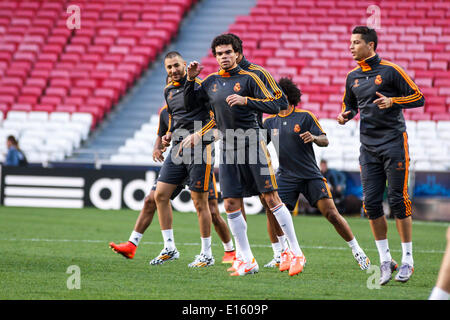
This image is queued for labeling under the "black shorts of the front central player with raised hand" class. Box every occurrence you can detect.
[219,140,278,198]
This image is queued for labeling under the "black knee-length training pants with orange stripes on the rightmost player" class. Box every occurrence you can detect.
[359,132,412,219]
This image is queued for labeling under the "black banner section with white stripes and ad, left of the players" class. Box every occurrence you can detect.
[1,167,159,210]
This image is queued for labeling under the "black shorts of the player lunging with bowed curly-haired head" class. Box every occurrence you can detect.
[277,172,333,211]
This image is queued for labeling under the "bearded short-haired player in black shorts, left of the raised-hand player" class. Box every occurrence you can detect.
[150,51,220,267]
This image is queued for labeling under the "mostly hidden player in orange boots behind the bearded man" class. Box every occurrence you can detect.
[109,77,235,263]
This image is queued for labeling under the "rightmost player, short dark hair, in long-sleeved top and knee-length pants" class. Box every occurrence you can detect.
[337,26,425,285]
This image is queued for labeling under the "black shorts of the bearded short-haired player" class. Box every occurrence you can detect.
[158,144,214,192]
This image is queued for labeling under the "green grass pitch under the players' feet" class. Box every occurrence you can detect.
[0,207,448,300]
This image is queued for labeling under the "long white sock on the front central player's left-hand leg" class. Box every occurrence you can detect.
[227,210,253,262]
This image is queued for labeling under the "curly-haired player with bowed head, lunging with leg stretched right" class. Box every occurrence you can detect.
[264,78,370,270]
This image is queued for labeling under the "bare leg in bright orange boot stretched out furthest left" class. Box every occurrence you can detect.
[109,188,156,259]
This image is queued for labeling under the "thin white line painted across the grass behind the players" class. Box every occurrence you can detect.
[0,238,445,254]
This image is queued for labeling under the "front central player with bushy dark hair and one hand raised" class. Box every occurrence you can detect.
[184,35,306,276]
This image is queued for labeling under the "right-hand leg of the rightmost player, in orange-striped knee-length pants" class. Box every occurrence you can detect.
[385,133,414,282]
